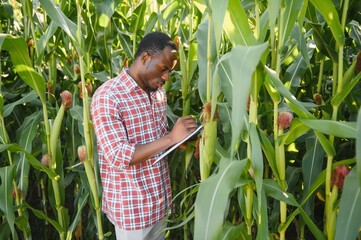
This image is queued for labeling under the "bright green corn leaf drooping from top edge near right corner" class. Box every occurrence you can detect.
[310,0,345,46]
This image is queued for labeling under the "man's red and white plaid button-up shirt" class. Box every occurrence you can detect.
[91,69,172,230]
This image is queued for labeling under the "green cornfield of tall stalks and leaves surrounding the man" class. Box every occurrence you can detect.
[0,0,361,240]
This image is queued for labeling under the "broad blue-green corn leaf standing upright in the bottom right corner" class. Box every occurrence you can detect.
[335,168,361,240]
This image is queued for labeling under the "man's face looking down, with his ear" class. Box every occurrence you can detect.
[138,47,177,92]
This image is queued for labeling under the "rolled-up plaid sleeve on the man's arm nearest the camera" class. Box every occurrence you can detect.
[91,89,135,169]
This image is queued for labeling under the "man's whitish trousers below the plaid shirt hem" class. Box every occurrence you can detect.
[115,221,165,240]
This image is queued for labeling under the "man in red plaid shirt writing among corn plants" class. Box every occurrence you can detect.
[91,32,197,240]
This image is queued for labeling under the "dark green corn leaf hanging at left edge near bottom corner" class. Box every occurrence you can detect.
[0,165,15,237]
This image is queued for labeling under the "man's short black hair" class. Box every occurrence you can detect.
[135,32,178,58]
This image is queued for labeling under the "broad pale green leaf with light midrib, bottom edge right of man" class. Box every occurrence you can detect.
[194,159,246,240]
